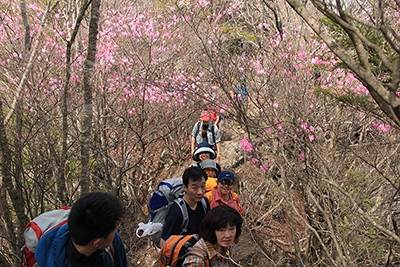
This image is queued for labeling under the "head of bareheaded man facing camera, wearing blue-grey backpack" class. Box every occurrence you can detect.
[182,167,207,203]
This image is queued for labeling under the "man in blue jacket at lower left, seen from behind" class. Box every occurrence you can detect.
[35,192,128,267]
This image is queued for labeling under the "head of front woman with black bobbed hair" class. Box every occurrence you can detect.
[200,205,243,247]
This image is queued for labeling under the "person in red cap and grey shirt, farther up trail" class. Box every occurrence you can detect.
[191,110,221,162]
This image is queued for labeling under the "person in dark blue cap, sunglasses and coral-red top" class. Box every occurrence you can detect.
[205,171,244,214]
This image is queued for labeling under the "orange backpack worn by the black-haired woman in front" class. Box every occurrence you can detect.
[158,234,210,267]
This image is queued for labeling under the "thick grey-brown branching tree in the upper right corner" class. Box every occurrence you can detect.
[286,0,400,125]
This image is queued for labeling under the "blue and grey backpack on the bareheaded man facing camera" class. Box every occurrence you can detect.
[148,178,207,247]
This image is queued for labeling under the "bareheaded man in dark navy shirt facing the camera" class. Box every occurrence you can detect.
[160,167,210,247]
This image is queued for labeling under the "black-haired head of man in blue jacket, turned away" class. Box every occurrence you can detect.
[68,192,124,249]
